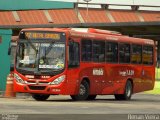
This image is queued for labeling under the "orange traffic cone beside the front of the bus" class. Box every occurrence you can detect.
[4,73,16,98]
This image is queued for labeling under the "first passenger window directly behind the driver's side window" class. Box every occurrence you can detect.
[81,40,92,61]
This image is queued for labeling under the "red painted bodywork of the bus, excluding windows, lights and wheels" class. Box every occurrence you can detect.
[14,28,155,95]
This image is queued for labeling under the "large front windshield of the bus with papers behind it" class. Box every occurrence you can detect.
[16,41,65,74]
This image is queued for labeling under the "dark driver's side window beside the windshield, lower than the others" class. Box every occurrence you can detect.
[68,42,80,68]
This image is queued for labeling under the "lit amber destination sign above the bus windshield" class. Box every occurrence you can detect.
[25,32,60,40]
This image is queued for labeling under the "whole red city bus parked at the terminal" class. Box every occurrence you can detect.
[14,28,156,100]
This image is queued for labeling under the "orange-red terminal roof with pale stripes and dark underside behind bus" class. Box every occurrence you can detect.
[0,2,160,59]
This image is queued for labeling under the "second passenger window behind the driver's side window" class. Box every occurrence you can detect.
[93,41,105,62]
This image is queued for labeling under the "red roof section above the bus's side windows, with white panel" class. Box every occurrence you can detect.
[70,28,154,45]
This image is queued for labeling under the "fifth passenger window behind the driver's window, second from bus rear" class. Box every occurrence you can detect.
[131,45,142,64]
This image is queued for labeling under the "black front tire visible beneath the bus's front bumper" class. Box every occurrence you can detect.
[32,94,50,101]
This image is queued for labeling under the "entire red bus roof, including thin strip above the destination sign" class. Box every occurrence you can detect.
[22,28,154,45]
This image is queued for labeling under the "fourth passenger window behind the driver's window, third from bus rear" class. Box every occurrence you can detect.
[119,43,130,63]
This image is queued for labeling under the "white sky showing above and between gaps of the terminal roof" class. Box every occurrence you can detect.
[43,0,160,11]
